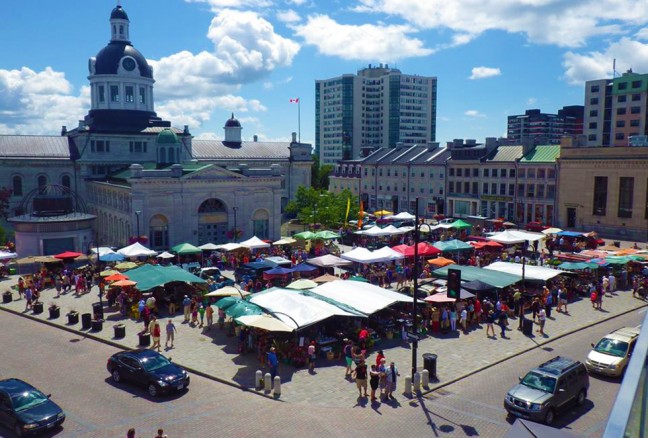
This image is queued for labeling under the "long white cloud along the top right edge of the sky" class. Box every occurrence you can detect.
[355,0,648,47]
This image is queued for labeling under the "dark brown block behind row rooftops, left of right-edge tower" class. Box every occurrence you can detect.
[507,105,583,144]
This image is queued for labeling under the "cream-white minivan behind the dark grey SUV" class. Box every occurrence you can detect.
[585,327,641,376]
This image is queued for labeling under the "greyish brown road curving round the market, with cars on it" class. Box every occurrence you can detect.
[0,312,644,438]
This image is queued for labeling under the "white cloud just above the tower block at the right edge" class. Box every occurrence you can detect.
[563,38,648,85]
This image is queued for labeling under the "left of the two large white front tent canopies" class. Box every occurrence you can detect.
[248,283,365,329]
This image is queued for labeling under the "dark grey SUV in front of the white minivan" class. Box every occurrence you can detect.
[504,356,589,424]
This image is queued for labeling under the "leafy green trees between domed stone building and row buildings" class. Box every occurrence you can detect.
[286,186,359,228]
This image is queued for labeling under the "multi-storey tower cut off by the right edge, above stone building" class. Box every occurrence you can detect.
[583,70,648,146]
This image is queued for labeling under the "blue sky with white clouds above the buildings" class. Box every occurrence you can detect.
[0,0,648,143]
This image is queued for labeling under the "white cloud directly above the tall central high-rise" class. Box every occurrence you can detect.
[294,15,433,61]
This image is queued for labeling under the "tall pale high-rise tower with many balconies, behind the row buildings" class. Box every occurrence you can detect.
[315,64,437,164]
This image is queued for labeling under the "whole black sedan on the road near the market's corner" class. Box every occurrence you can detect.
[106,350,189,397]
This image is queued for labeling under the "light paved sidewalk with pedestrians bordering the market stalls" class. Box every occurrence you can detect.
[0,276,648,406]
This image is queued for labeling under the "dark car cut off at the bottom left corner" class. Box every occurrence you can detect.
[0,379,65,436]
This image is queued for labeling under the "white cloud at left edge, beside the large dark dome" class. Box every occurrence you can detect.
[0,67,90,134]
